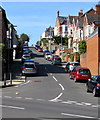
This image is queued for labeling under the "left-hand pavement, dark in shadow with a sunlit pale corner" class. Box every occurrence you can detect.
[0,51,26,88]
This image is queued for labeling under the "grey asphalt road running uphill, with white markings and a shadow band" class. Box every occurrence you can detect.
[0,48,99,120]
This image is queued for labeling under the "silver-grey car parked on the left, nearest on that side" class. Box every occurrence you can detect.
[22,62,37,75]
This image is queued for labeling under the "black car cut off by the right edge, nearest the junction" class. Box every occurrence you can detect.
[86,75,100,97]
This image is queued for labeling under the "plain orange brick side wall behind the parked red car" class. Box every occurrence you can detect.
[80,34,100,75]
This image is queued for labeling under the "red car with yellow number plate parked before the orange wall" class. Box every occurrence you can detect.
[70,67,91,82]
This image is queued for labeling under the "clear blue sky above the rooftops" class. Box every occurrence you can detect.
[1,1,98,45]
